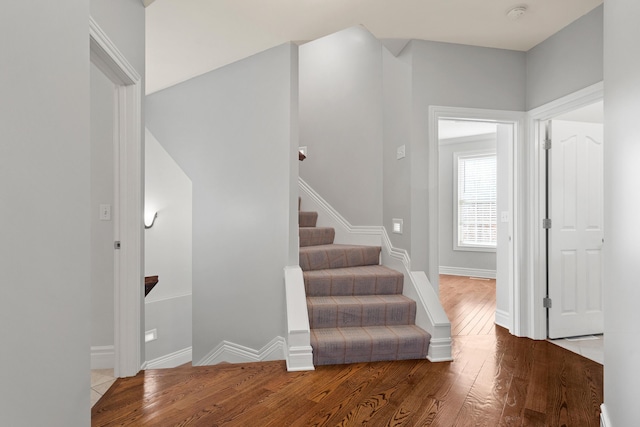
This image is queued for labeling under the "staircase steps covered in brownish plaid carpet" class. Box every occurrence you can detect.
[298,206,431,366]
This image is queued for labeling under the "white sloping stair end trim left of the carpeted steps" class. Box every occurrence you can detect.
[284,265,314,371]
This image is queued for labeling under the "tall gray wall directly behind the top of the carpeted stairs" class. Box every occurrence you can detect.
[299,27,383,225]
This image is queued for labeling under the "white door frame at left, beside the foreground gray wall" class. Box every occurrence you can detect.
[89,18,144,377]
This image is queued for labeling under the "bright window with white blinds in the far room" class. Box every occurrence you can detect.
[454,152,498,251]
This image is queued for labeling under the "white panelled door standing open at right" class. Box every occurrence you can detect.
[548,120,604,338]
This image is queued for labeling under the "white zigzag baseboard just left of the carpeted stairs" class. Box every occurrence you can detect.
[197,337,287,366]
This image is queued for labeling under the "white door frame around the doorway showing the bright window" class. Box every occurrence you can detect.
[427,106,526,336]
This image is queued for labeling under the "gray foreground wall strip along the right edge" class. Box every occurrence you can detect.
[604,0,640,427]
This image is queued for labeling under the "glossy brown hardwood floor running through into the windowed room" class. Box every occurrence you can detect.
[92,276,602,427]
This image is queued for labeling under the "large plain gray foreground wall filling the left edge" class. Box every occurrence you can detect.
[0,0,144,427]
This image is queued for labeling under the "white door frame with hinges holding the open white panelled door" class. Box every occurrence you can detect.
[527,82,604,340]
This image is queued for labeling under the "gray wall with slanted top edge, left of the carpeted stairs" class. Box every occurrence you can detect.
[146,44,298,363]
